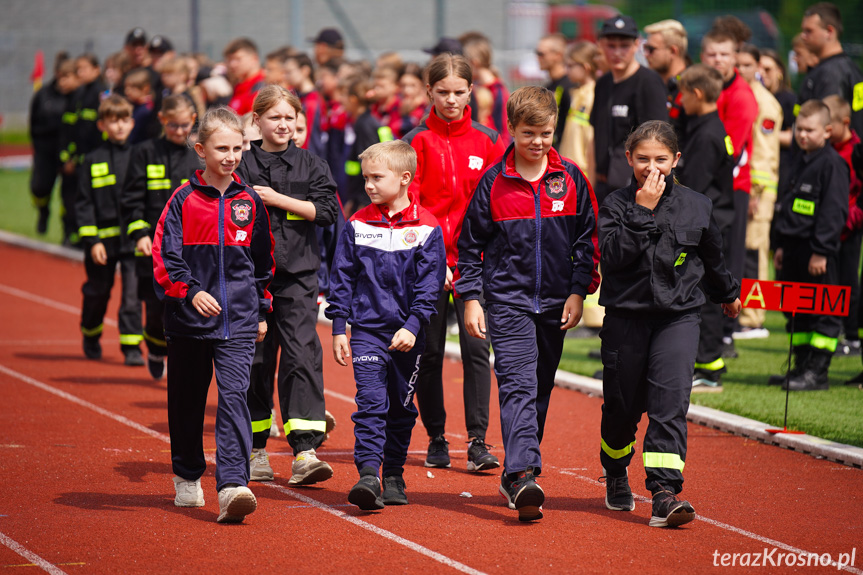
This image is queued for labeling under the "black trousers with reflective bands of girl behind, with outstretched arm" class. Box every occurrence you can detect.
[248,279,326,454]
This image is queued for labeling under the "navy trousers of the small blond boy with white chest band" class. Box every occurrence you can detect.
[351,327,425,477]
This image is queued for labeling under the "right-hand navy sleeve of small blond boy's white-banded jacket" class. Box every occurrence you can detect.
[404,226,446,335]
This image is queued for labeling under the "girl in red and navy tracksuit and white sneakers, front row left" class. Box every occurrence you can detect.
[153,108,274,523]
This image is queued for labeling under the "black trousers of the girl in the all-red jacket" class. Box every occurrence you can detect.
[416,291,491,439]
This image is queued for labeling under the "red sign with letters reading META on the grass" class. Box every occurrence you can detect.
[740,278,851,316]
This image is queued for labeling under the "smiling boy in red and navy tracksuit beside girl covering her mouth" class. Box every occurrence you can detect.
[455,86,599,521]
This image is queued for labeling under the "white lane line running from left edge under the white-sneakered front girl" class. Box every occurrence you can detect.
[0,365,484,575]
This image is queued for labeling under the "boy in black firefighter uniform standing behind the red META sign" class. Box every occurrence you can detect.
[773,100,851,391]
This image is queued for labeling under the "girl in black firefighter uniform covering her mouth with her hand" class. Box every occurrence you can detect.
[599,121,740,527]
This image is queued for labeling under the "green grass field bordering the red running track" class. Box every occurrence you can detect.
[0,164,863,447]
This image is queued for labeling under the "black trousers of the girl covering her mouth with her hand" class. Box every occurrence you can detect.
[599,308,700,493]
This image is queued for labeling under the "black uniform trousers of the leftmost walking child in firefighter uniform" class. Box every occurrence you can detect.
[81,250,142,349]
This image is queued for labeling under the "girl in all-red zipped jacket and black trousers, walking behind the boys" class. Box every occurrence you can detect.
[404,54,504,471]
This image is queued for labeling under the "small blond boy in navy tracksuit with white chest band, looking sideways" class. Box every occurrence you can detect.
[326,141,446,510]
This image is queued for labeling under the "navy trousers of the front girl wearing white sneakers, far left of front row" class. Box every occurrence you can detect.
[168,336,255,490]
